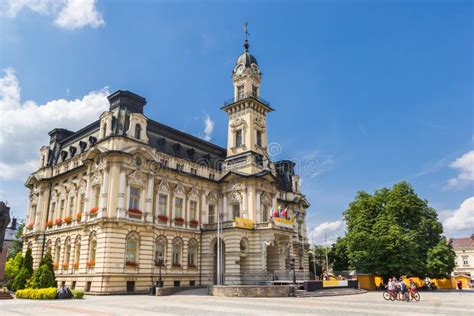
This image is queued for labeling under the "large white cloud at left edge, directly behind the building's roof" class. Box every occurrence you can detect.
[0,69,109,181]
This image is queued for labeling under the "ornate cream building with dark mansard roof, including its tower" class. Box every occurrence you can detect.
[24,40,309,293]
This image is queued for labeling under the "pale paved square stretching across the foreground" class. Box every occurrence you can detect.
[0,290,474,316]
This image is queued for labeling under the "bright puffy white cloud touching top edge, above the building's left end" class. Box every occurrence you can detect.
[54,0,105,30]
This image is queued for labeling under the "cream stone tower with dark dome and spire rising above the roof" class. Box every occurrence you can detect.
[222,29,273,174]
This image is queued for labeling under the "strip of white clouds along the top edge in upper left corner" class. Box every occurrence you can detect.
[0,0,105,30]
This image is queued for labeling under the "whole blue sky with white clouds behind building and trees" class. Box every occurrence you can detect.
[0,0,474,244]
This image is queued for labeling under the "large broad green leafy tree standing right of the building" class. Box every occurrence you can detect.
[344,182,452,279]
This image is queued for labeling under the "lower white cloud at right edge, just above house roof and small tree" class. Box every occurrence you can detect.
[440,196,474,236]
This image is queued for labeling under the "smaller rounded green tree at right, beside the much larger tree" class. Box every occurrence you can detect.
[426,238,456,278]
